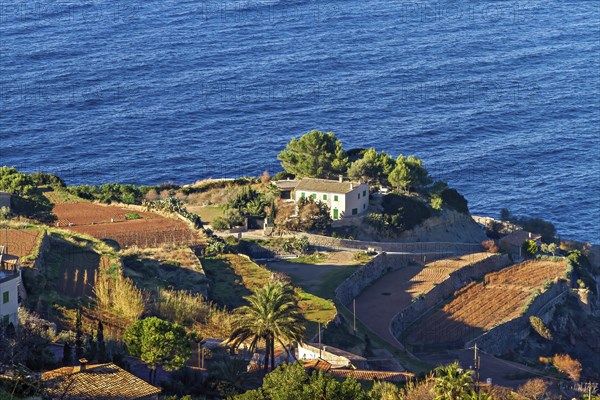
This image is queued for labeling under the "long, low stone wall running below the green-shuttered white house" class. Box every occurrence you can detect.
[303,234,482,255]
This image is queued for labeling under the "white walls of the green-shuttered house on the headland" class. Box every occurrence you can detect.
[294,183,369,220]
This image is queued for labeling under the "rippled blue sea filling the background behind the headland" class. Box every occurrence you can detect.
[0,0,600,243]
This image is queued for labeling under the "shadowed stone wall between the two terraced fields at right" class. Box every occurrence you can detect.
[390,254,511,339]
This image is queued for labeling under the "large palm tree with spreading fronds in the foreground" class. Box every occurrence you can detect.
[228,282,304,373]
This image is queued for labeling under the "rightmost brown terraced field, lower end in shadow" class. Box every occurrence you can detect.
[407,261,566,345]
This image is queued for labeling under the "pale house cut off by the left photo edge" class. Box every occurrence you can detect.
[0,246,21,328]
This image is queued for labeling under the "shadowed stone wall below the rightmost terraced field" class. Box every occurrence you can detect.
[465,280,569,356]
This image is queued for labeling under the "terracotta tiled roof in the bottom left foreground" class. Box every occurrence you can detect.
[42,363,160,400]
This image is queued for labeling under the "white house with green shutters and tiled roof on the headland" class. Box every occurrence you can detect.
[293,176,369,220]
